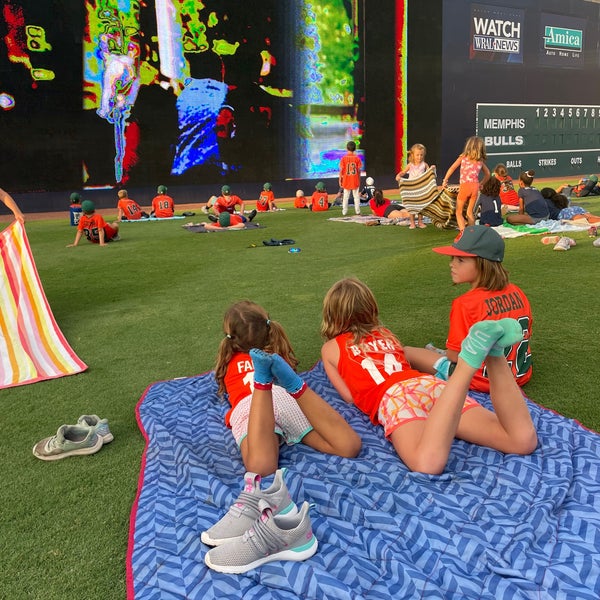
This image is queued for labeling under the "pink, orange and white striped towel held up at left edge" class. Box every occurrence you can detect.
[0,221,87,389]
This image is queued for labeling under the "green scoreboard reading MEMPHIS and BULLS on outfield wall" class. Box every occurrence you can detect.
[476,104,600,178]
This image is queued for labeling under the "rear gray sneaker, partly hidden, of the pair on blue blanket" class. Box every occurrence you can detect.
[200,469,298,546]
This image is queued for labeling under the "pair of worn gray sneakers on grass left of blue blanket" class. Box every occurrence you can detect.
[33,415,114,461]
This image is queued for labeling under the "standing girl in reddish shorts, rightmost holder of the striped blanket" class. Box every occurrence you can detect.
[442,136,490,231]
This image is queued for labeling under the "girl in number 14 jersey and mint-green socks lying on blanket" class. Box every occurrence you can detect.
[321,278,537,475]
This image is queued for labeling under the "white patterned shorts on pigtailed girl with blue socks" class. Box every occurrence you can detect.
[229,385,313,447]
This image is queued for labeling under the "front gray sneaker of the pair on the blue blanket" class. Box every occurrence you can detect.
[204,500,319,574]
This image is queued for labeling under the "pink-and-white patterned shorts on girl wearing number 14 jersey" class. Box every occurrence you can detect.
[377,375,480,437]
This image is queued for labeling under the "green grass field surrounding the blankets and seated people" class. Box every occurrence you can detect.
[0,193,600,600]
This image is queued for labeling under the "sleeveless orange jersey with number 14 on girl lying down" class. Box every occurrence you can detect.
[335,329,421,424]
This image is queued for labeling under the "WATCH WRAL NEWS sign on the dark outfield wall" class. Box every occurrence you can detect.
[469,4,525,63]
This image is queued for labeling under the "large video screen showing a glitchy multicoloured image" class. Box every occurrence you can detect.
[0,0,365,192]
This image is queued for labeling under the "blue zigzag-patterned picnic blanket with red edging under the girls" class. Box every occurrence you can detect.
[127,363,600,600]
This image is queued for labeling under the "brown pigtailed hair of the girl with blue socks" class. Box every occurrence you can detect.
[215,300,298,396]
